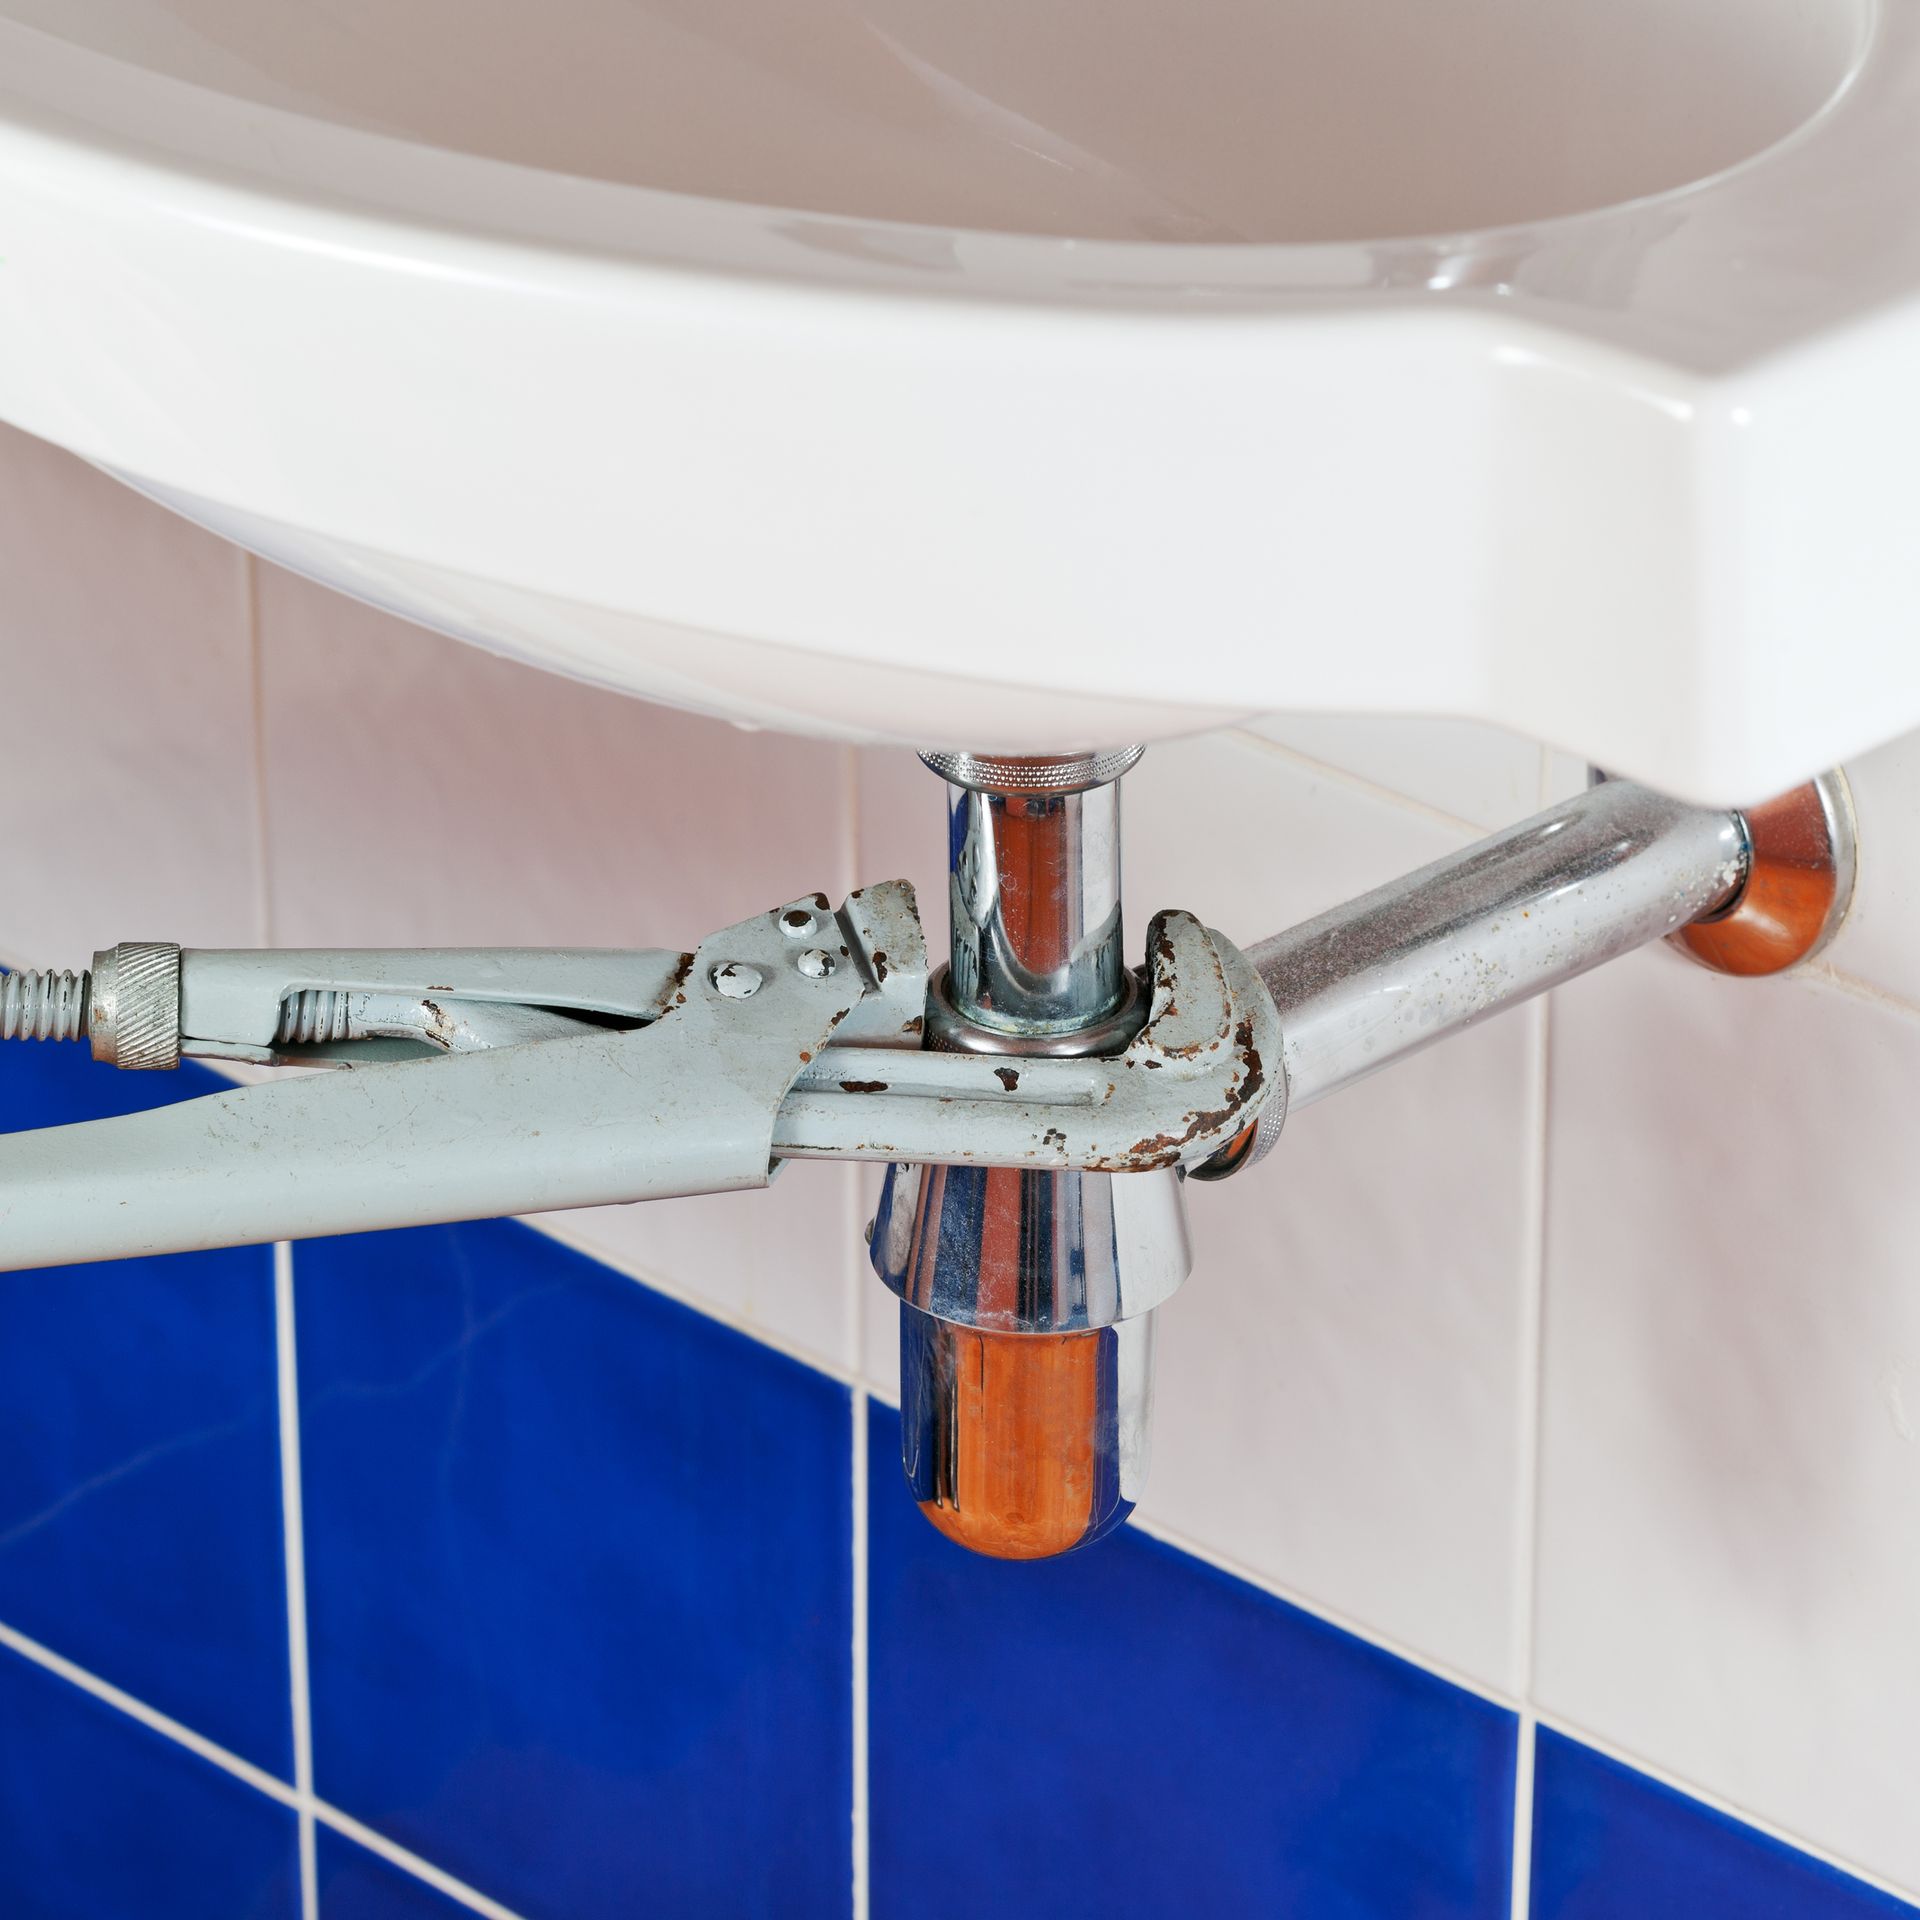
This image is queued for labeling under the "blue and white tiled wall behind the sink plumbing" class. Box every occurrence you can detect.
[0,434,1920,1920]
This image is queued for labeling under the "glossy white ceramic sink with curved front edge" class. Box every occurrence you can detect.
[0,0,1920,801]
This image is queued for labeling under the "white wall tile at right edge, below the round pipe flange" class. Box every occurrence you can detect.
[1536,954,1920,1891]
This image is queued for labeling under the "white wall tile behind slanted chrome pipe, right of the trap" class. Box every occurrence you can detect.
[1127,739,1532,1690]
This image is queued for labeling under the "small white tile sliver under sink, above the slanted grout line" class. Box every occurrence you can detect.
[1252,714,1540,829]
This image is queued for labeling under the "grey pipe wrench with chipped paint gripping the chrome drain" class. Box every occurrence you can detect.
[0,881,1279,1271]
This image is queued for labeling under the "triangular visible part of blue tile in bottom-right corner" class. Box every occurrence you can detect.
[1532,1728,1914,1920]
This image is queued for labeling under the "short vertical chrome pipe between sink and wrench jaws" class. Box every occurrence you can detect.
[947,762,1129,1035]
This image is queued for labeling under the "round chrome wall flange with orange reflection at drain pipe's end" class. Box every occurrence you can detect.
[1672,768,1859,977]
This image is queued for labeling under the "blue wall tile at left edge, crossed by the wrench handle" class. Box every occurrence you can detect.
[0,1044,292,1778]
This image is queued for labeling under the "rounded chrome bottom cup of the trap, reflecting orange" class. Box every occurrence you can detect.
[900,1302,1154,1559]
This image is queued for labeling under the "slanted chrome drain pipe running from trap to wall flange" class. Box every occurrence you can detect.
[1248,781,1747,1112]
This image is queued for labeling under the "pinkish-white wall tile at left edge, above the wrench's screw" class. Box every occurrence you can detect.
[0,426,261,968]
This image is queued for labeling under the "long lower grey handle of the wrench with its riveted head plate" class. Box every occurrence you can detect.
[0,885,910,1271]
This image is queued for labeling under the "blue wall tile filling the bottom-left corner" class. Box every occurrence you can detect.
[0,1649,300,1920]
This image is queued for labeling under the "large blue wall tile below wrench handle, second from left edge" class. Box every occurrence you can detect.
[296,1223,852,1920]
